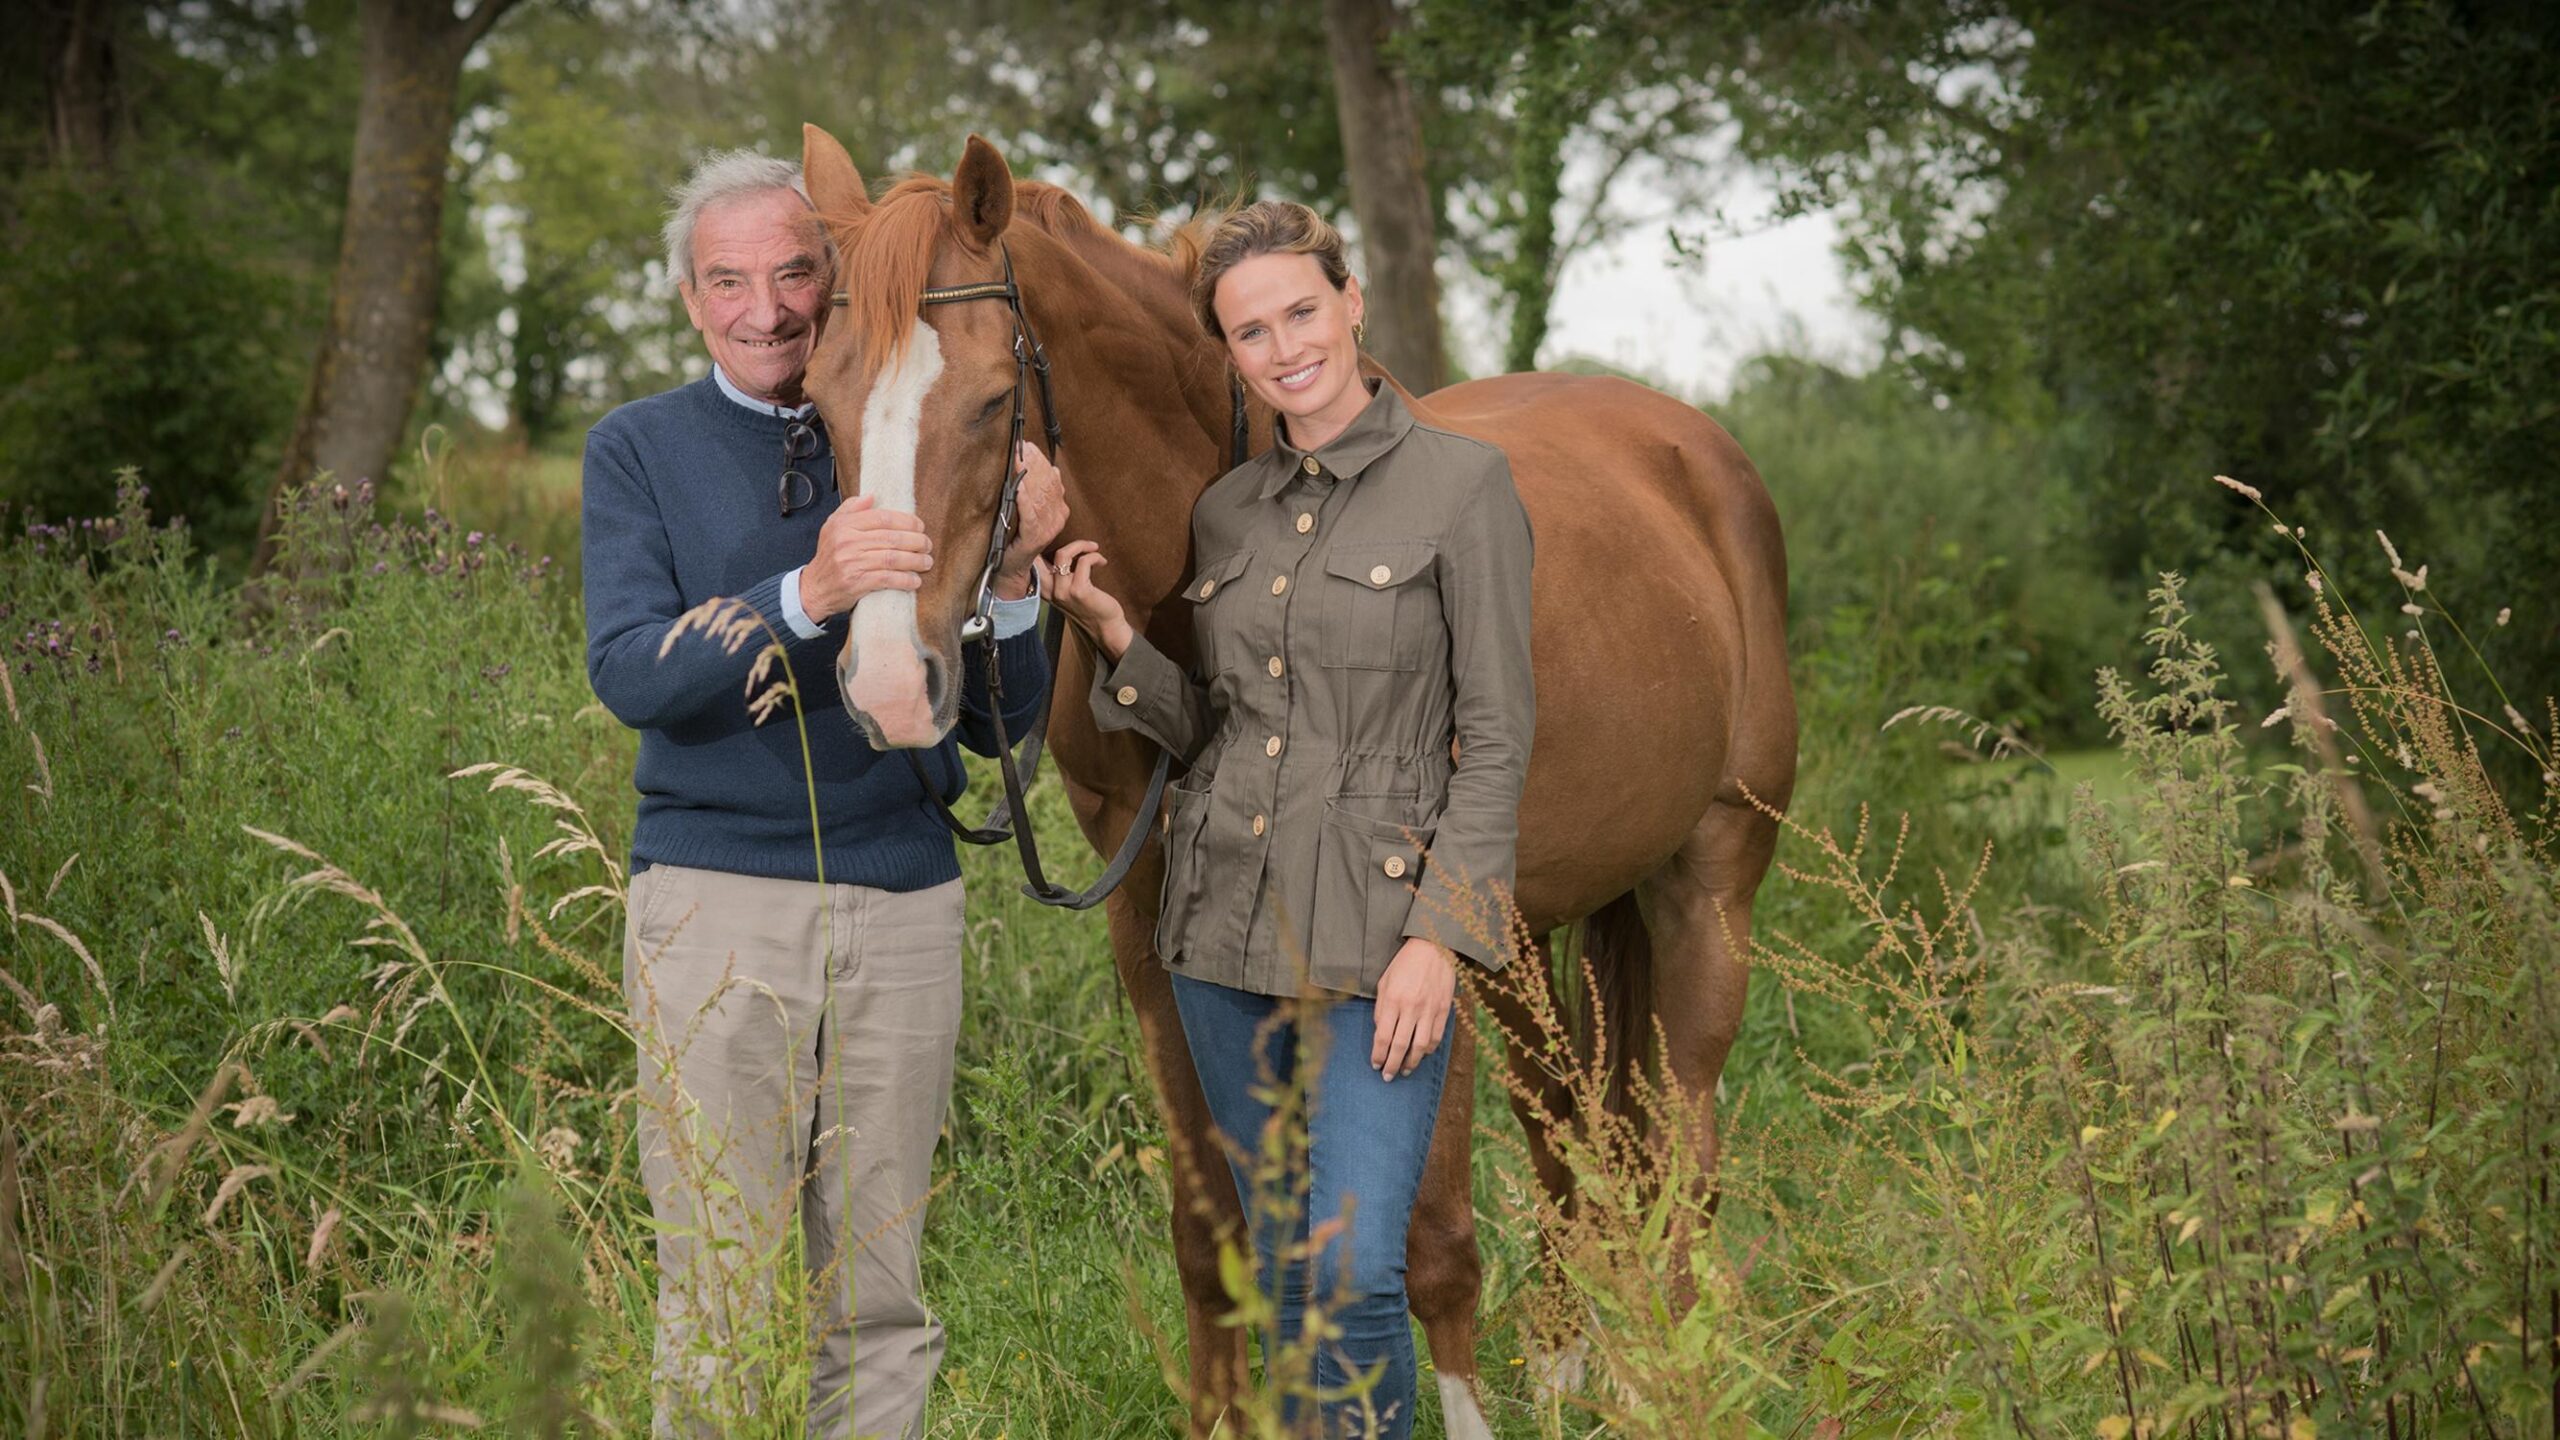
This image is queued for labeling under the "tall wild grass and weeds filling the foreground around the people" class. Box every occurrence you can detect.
[0,461,2560,1437]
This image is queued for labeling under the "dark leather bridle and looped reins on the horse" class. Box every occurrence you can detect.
[827,241,1247,910]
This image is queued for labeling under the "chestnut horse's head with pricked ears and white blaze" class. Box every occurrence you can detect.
[801,126,1037,748]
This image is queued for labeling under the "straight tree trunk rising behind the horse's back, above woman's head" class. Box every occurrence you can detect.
[1324,0,1446,395]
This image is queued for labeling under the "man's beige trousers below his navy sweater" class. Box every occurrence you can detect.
[622,866,963,1440]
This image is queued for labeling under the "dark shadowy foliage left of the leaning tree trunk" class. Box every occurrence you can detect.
[0,0,353,571]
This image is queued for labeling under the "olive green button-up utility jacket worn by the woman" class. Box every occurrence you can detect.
[1093,387,1536,997]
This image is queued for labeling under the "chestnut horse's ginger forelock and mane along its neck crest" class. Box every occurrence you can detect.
[822,174,1216,374]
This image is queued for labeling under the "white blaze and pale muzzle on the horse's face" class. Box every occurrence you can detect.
[837,318,952,751]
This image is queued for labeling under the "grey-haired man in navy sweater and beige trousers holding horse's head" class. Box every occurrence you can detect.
[584,151,1065,1437]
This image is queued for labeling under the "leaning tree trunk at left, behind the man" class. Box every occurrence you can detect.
[253,0,515,571]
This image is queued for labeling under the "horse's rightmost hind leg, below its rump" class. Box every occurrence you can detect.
[1638,784,1787,1240]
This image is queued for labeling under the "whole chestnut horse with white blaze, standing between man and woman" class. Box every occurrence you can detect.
[804,126,1795,1437]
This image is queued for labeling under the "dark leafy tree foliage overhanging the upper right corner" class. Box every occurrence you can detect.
[1731,0,2560,689]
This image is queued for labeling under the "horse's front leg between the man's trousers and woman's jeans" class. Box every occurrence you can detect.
[1103,871,1247,1437]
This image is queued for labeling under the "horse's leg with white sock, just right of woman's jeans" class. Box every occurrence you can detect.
[1405,1009,1495,1440]
